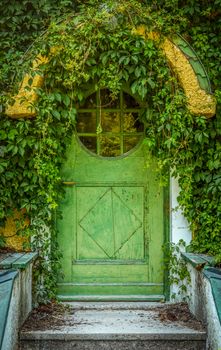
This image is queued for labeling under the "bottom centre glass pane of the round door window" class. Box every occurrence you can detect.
[100,135,121,157]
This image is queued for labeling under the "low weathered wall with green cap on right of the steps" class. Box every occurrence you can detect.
[181,253,221,350]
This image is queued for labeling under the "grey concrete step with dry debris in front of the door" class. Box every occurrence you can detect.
[20,302,206,350]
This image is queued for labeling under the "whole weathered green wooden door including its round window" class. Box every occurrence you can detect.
[58,89,165,300]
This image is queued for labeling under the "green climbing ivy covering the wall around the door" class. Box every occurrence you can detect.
[0,0,221,301]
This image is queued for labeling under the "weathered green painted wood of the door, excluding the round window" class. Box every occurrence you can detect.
[58,135,164,300]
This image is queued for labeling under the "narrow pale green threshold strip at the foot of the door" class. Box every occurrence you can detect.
[57,294,165,302]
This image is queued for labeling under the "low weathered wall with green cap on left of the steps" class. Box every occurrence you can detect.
[0,253,38,350]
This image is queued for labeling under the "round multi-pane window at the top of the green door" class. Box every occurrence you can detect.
[77,89,144,157]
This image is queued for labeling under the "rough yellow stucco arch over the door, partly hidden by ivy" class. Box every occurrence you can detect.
[6,26,216,118]
